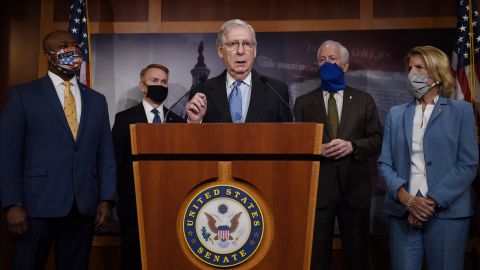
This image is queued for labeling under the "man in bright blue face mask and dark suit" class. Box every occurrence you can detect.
[294,41,383,269]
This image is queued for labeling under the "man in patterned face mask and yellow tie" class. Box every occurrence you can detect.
[0,31,115,270]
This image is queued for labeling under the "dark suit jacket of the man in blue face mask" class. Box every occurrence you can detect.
[294,87,383,207]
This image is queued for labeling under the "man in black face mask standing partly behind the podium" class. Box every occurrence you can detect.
[112,64,185,270]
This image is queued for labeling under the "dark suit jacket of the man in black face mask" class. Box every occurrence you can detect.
[112,103,186,221]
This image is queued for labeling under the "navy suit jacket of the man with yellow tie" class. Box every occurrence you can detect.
[0,76,115,218]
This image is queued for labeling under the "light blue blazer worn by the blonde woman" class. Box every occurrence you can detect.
[377,97,478,218]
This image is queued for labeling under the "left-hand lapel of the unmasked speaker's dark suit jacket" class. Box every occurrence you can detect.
[208,70,232,122]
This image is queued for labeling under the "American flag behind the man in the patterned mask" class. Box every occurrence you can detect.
[68,0,91,87]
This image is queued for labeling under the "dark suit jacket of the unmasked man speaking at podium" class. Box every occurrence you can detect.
[190,70,292,123]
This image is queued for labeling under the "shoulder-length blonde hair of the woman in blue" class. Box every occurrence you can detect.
[405,46,455,97]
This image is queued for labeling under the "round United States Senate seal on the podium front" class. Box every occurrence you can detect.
[183,185,264,267]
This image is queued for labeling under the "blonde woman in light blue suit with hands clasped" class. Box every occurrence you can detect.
[378,46,478,270]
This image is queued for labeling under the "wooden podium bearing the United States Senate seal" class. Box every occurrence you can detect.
[130,123,323,270]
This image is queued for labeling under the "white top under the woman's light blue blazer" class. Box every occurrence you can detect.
[408,96,438,197]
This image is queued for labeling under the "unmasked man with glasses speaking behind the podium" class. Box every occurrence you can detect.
[185,19,292,123]
